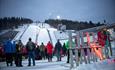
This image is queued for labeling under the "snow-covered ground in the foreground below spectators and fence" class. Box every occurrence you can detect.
[0,57,115,70]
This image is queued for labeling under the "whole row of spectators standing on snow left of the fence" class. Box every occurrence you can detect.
[4,38,67,67]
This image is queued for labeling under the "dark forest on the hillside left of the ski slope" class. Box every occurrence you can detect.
[0,17,33,30]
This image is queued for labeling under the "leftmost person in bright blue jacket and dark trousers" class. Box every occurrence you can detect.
[4,40,13,66]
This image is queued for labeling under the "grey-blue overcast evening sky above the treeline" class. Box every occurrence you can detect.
[0,0,115,23]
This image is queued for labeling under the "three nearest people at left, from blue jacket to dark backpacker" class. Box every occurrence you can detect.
[4,38,36,67]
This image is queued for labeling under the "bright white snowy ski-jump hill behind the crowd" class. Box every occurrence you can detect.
[14,23,68,45]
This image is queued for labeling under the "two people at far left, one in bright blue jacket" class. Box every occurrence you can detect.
[4,40,23,66]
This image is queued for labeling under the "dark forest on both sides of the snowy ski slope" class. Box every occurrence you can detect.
[0,17,104,30]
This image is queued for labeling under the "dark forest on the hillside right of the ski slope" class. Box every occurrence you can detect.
[45,19,104,30]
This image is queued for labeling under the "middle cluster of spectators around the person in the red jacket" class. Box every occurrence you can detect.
[36,40,67,62]
